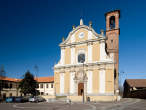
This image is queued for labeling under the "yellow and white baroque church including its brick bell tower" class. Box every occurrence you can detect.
[54,10,120,101]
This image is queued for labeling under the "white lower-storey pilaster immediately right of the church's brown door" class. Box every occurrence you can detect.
[87,71,93,94]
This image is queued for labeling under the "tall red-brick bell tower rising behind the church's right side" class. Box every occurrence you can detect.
[105,10,120,92]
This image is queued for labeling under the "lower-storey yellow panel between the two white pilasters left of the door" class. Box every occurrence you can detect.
[64,72,70,94]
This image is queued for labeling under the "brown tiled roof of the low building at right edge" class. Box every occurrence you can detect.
[126,79,146,87]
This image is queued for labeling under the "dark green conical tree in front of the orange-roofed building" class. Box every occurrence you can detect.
[19,71,37,95]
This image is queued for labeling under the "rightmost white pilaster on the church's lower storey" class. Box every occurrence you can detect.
[99,69,105,94]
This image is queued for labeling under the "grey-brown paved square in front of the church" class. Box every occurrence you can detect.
[0,99,146,110]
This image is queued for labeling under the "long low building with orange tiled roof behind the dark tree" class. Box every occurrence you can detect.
[0,77,55,99]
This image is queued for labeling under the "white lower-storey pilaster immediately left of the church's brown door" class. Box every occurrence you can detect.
[70,72,75,94]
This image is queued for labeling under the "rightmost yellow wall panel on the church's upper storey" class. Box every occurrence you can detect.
[92,42,100,61]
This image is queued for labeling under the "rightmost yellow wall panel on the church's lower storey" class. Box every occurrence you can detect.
[105,69,114,93]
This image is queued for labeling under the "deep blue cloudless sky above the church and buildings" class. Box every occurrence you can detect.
[0,0,146,84]
